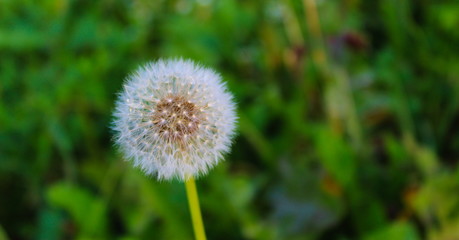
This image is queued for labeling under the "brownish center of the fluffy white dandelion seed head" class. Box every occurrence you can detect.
[152,95,203,141]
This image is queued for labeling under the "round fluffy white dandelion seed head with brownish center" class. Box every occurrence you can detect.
[113,59,236,180]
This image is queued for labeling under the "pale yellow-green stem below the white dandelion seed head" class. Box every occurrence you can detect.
[185,176,206,240]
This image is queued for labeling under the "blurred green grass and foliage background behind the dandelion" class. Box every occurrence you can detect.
[0,0,459,240]
